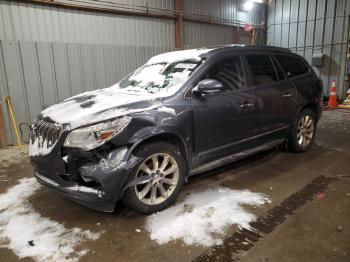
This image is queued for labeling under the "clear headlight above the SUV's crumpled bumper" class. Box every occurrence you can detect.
[64,116,131,150]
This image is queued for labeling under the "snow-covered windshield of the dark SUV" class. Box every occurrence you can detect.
[117,60,202,95]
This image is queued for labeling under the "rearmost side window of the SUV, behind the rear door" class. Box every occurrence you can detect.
[276,55,309,78]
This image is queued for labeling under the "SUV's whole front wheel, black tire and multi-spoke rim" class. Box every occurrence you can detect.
[123,142,186,214]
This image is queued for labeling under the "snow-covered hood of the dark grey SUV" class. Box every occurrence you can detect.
[40,87,162,129]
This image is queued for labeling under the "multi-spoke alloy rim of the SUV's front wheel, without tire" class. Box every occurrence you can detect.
[134,153,179,205]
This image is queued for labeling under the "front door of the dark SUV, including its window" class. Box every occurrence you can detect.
[191,56,256,165]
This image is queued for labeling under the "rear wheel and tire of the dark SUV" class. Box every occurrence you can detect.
[288,108,317,153]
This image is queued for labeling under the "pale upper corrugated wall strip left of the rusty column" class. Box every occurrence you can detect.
[0,0,175,48]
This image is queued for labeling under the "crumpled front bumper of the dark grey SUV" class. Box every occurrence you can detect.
[31,147,137,212]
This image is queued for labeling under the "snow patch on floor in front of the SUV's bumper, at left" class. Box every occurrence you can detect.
[0,178,100,261]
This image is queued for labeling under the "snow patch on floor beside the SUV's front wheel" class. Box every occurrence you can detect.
[146,187,269,246]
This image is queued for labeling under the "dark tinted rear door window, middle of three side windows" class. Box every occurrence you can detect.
[247,55,278,85]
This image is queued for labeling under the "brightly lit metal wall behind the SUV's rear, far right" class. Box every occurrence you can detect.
[267,0,350,97]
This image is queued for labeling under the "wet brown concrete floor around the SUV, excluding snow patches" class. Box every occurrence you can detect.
[0,111,350,262]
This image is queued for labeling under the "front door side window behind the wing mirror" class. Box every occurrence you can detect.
[206,57,246,90]
